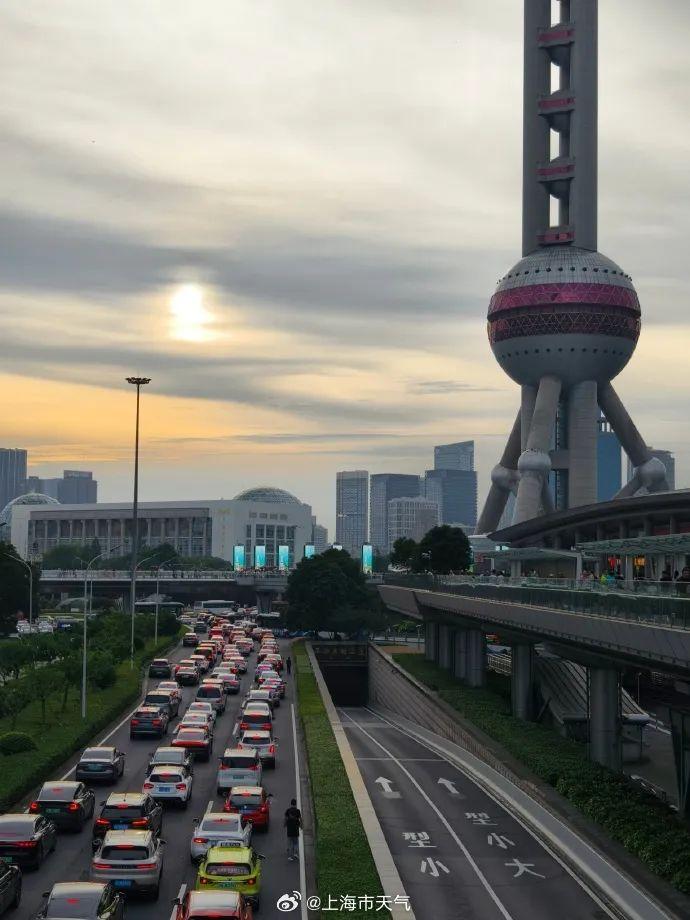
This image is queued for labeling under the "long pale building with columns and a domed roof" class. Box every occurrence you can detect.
[10,487,312,569]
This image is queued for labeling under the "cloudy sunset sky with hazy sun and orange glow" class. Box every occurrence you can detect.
[0,0,690,533]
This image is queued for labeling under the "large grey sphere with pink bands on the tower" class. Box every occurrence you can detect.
[488,246,640,386]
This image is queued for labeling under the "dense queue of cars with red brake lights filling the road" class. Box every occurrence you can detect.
[0,612,290,920]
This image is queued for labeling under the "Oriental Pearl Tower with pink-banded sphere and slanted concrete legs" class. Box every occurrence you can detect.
[477,0,668,533]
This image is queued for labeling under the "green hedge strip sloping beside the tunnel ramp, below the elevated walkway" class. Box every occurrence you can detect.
[393,653,690,894]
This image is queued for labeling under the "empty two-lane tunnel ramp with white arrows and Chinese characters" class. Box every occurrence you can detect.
[338,708,613,920]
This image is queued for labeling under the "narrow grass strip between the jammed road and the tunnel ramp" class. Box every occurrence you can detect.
[293,642,390,920]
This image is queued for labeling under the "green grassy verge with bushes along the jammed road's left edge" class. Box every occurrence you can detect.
[0,636,176,811]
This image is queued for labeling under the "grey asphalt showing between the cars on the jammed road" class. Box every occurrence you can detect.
[13,643,300,920]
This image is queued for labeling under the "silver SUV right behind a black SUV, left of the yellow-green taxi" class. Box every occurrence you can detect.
[89,831,165,901]
